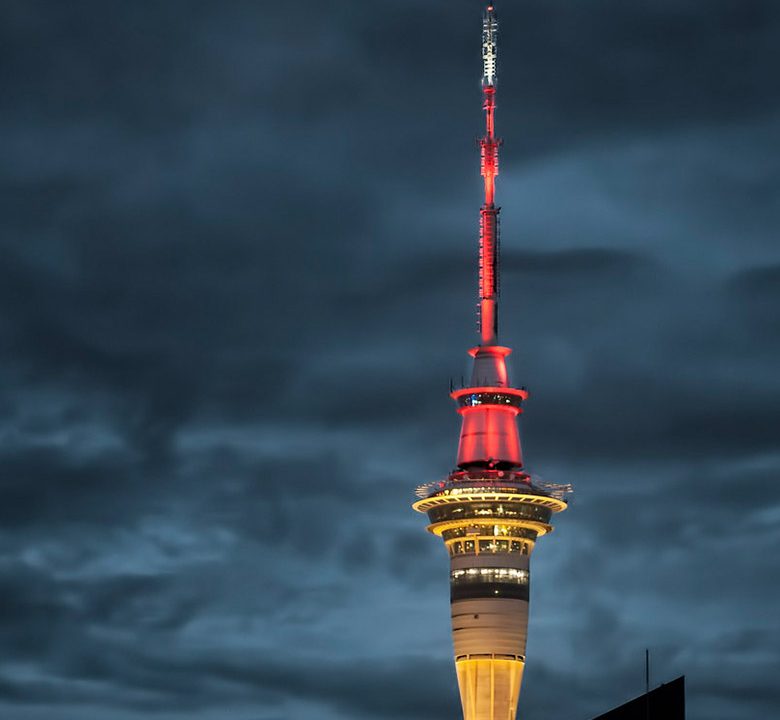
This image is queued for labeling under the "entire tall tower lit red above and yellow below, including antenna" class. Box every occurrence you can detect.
[413,5,570,720]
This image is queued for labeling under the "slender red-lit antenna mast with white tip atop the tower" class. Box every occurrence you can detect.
[479,4,501,345]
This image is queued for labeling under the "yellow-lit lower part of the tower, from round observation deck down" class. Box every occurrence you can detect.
[414,476,566,720]
